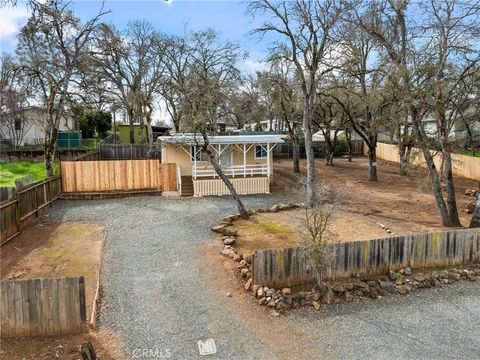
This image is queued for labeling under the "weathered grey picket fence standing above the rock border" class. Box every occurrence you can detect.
[253,229,480,287]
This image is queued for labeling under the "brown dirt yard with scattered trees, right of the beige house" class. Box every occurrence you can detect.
[229,158,478,253]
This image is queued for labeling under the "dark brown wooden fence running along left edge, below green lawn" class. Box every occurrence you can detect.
[0,176,61,245]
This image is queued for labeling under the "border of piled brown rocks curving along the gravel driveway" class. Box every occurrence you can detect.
[211,203,480,316]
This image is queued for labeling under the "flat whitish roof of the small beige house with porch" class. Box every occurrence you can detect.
[158,133,286,145]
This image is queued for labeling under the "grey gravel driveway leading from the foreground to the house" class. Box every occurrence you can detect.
[43,195,480,359]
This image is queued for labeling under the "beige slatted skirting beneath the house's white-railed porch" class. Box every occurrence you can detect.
[193,176,270,196]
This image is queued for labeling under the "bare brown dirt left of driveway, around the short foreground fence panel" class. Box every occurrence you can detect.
[0,221,122,359]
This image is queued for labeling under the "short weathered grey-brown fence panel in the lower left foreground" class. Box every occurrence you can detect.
[0,277,87,337]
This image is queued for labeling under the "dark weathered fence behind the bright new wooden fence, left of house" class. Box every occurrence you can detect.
[99,144,161,160]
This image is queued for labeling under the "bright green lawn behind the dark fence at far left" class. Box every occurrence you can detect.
[0,161,58,186]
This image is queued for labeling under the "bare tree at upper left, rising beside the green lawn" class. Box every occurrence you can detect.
[17,1,105,176]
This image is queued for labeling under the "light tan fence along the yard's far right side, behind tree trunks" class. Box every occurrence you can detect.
[370,143,480,180]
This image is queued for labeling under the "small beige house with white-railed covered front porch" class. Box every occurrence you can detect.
[158,133,284,196]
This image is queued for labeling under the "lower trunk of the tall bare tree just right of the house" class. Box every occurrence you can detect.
[303,95,315,205]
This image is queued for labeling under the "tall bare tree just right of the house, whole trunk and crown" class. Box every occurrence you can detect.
[250,0,342,202]
